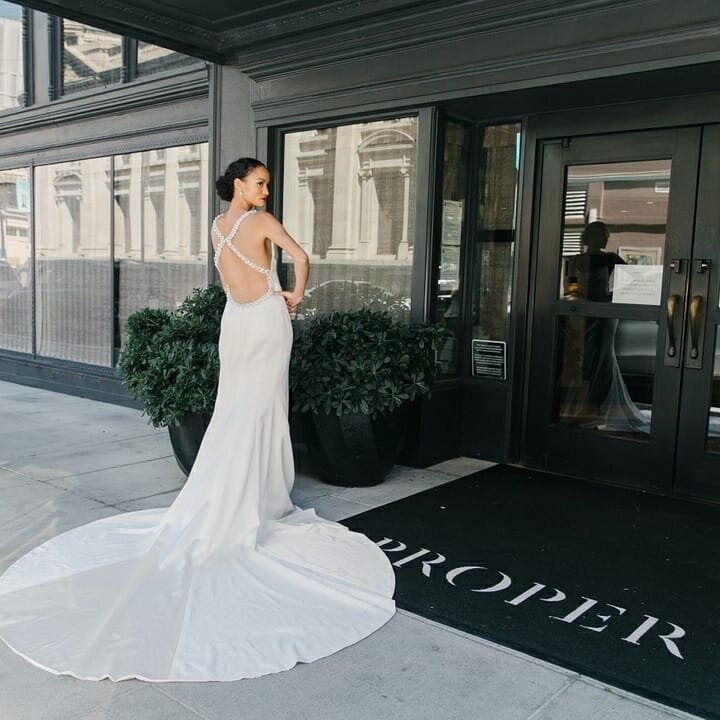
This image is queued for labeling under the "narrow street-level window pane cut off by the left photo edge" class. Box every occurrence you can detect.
[0,168,32,352]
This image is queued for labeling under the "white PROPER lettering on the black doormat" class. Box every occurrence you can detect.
[376,537,686,660]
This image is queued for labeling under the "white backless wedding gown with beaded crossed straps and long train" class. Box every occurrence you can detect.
[0,215,395,682]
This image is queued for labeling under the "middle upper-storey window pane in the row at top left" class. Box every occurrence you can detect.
[62,19,123,93]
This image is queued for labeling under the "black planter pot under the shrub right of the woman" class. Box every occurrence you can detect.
[299,413,404,487]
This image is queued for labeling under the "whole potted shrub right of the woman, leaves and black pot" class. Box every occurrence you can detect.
[290,309,444,486]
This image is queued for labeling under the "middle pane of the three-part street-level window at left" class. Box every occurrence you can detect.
[35,158,112,365]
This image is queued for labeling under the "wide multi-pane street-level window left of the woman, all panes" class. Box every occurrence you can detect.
[0,143,208,366]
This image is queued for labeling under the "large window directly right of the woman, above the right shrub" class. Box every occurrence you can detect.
[283,117,417,318]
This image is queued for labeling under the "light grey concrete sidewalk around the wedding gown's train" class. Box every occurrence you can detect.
[0,382,695,720]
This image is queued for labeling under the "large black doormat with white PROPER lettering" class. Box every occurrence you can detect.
[343,465,720,718]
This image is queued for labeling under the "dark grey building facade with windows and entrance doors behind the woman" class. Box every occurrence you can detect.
[0,0,720,501]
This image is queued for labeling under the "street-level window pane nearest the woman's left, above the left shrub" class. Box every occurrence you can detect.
[113,143,208,359]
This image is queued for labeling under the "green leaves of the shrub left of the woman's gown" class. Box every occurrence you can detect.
[118,285,225,427]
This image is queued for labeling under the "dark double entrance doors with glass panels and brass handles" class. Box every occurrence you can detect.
[523,125,720,500]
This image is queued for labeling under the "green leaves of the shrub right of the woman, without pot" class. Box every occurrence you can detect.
[290,309,445,419]
